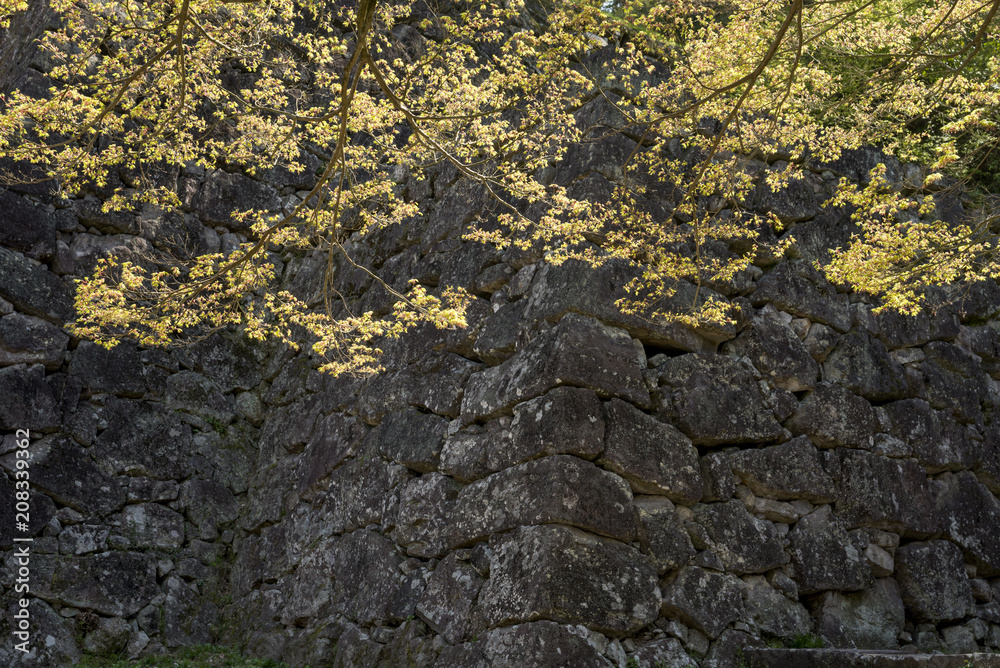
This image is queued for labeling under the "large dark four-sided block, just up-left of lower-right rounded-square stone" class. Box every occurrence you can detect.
[837,450,941,537]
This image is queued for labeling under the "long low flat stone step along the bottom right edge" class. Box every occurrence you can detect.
[739,648,1000,668]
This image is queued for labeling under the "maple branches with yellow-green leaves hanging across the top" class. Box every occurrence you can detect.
[0,0,1000,373]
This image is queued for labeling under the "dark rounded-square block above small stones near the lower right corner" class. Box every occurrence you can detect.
[895,540,975,624]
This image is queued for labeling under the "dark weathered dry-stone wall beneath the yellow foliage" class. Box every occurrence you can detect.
[0,64,1000,668]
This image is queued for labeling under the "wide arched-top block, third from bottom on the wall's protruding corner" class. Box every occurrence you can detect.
[452,455,635,546]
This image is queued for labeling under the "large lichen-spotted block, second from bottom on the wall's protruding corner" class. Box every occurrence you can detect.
[480,525,659,637]
